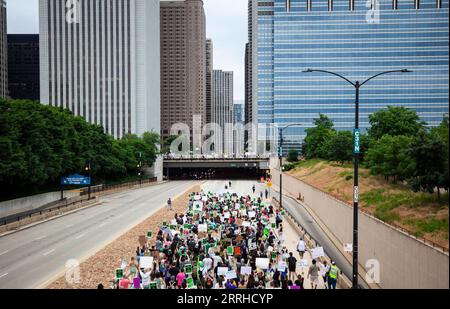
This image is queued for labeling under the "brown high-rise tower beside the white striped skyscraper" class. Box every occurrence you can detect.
[161,0,206,139]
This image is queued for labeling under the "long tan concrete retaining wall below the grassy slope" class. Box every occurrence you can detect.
[272,169,449,289]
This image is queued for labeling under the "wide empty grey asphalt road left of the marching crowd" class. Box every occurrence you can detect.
[0,181,195,289]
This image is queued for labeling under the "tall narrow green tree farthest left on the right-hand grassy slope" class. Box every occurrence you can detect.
[302,114,336,159]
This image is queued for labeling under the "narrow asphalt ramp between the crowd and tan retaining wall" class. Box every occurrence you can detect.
[271,190,368,288]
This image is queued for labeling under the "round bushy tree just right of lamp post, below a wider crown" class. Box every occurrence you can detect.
[366,135,415,183]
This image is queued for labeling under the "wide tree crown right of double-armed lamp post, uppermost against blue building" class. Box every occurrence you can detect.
[369,106,424,140]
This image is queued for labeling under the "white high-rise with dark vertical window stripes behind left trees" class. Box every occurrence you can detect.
[39,0,160,137]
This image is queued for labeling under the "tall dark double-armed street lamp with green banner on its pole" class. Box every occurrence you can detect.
[303,69,412,289]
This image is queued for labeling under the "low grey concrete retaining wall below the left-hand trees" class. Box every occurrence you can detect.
[0,191,80,218]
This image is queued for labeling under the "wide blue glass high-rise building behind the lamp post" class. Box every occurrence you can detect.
[253,0,449,153]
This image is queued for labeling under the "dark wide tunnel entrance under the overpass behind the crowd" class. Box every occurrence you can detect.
[164,168,268,180]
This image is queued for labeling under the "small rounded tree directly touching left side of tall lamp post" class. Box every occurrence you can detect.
[323,131,353,163]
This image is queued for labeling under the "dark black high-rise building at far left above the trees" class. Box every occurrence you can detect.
[8,34,40,101]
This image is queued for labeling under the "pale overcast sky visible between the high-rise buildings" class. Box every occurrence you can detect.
[7,0,247,100]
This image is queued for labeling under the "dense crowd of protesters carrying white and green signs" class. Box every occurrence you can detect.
[110,183,338,290]
